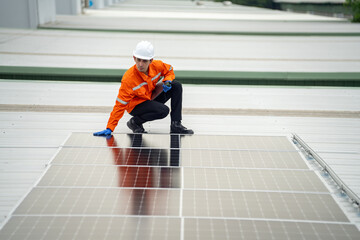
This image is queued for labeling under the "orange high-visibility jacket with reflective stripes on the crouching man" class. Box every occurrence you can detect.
[106,60,175,131]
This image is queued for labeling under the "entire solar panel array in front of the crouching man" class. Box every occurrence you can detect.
[0,133,359,239]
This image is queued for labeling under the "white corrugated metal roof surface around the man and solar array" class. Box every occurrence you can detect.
[0,1,360,237]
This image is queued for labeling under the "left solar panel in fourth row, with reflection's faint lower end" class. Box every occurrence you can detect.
[14,187,180,216]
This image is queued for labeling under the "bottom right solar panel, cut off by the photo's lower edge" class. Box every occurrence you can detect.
[184,218,359,240]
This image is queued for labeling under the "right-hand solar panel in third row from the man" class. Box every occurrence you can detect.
[184,168,328,192]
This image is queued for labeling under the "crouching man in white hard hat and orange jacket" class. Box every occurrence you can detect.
[94,41,194,136]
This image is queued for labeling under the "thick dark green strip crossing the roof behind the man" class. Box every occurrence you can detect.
[0,66,360,87]
